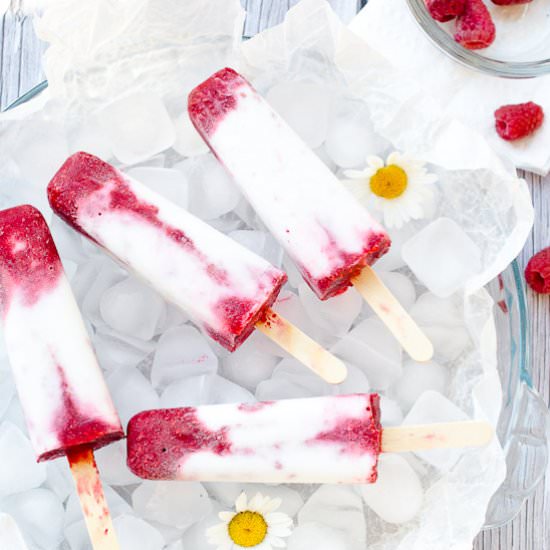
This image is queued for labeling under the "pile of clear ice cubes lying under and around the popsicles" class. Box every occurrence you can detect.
[0,76,508,550]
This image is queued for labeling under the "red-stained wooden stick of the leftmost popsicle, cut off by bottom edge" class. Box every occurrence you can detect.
[67,448,120,550]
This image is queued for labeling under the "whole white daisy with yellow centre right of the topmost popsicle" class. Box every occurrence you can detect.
[344,152,437,228]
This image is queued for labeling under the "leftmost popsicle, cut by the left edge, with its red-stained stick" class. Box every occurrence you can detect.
[0,205,124,549]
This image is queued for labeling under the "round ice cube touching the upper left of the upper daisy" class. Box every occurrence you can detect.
[325,111,387,168]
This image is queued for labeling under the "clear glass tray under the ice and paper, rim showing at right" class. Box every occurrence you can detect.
[8,83,550,529]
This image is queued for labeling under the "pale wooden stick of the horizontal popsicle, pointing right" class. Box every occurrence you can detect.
[382,420,495,453]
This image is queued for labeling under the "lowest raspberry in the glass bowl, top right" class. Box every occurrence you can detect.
[455,0,496,50]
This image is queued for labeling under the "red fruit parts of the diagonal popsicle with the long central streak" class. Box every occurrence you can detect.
[48,153,287,351]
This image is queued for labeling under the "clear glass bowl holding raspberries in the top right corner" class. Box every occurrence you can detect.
[407,0,550,78]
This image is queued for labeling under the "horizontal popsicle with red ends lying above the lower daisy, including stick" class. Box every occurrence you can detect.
[127,394,493,483]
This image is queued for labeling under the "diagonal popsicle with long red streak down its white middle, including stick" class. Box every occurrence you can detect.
[48,153,346,383]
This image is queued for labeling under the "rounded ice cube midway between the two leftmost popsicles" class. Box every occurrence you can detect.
[99,277,166,341]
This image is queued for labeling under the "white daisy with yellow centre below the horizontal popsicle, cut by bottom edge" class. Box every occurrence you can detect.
[206,493,293,550]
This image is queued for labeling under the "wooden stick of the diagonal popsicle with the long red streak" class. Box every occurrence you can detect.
[256,309,348,384]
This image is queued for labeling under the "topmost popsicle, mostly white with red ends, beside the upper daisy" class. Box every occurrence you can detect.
[188,68,433,360]
